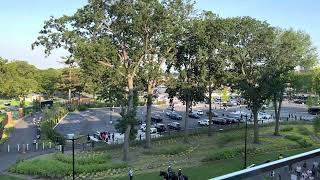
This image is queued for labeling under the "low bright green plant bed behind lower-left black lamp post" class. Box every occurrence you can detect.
[10,154,127,178]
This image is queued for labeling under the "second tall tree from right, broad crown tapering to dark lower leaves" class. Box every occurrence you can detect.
[227,17,275,143]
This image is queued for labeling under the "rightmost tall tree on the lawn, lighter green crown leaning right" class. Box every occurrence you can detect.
[267,30,317,135]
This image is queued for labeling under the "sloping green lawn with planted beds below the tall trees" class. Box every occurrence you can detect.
[11,123,320,180]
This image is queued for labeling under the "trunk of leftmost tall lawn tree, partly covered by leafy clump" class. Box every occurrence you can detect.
[123,75,133,161]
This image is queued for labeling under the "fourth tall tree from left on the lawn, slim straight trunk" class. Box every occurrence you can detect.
[197,11,228,136]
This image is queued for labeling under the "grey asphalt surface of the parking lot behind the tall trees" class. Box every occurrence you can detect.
[56,102,314,138]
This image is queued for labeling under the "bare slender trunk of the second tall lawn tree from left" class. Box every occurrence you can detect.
[146,82,153,148]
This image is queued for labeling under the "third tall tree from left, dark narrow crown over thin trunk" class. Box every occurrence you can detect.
[167,16,205,141]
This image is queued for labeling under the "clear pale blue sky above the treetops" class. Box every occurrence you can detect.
[0,0,320,68]
